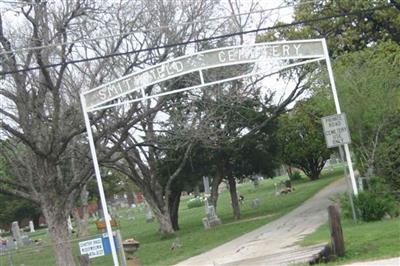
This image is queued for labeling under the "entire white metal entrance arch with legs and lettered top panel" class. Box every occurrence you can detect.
[80,39,358,266]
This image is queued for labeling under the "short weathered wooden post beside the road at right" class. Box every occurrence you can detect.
[328,205,345,257]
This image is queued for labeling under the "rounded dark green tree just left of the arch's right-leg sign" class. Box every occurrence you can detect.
[275,95,333,180]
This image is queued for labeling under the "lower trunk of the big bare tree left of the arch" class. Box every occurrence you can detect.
[42,199,75,266]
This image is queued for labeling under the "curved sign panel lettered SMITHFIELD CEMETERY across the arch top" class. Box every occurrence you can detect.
[83,40,324,108]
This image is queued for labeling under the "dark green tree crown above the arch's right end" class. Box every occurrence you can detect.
[260,0,400,57]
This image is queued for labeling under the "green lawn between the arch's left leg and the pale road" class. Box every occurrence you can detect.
[121,168,341,265]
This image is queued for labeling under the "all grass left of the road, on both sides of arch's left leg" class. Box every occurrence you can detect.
[0,169,342,266]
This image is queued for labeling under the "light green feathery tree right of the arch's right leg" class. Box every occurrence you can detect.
[334,42,400,174]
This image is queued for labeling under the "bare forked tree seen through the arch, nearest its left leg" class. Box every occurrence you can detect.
[93,0,213,234]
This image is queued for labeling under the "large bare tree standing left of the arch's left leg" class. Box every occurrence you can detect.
[0,0,157,266]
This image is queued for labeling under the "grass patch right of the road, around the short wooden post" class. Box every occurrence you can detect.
[301,218,400,265]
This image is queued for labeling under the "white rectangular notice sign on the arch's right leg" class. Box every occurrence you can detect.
[322,113,351,148]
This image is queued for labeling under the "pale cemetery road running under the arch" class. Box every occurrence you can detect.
[177,179,346,266]
